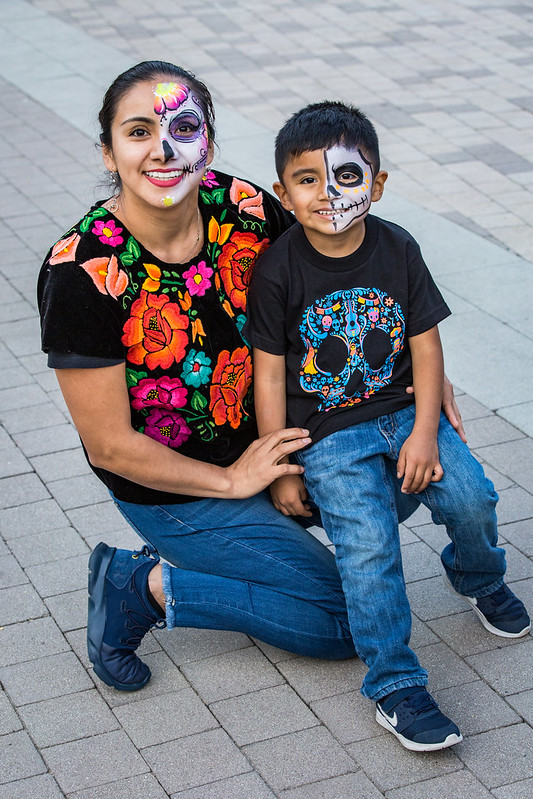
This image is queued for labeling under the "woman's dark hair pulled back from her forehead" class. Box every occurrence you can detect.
[98,61,215,147]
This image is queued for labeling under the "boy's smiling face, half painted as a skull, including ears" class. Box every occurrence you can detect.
[274,144,387,242]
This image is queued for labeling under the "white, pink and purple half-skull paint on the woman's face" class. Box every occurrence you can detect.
[150,83,209,206]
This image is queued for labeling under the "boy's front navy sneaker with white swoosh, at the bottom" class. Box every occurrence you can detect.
[376,685,463,752]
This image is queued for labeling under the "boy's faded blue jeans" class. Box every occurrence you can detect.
[297,406,505,700]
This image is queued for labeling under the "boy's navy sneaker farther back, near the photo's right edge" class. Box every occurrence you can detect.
[459,583,531,638]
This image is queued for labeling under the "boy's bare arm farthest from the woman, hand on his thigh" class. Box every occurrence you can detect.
[397,326,444,494]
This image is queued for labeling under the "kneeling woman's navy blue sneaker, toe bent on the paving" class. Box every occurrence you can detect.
[87,543,165,691]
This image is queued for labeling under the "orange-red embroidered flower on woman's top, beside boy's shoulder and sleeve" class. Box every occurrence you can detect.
[218,231,270,311]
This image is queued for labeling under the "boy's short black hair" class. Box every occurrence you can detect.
[275,100,380,181]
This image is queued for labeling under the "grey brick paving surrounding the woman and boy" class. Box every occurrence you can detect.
[0,0,533,799]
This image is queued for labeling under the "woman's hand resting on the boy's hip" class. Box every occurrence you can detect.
[226,427,311,499]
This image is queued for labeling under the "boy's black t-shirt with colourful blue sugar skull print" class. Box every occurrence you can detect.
[245,215,451,441]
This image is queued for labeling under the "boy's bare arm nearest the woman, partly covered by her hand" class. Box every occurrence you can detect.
[254,347,312,516]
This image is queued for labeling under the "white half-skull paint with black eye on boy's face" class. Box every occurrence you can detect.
[324,145,373,231]
